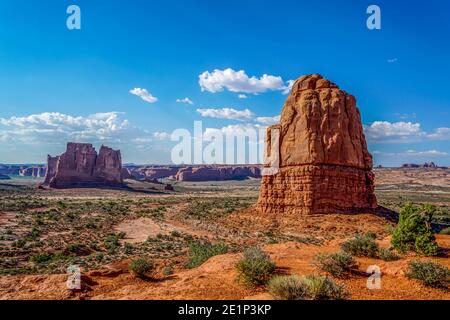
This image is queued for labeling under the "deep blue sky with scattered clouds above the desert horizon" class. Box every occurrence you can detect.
[0,0,450,166]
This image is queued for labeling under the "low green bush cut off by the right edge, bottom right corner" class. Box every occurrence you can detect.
[406,260,450,288]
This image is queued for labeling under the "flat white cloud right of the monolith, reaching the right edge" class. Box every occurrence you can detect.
[364,121,450,143]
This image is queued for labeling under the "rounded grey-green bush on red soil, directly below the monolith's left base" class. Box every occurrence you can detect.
[236,247,275,286]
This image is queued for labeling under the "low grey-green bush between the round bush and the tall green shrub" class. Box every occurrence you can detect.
[314,251,358,278]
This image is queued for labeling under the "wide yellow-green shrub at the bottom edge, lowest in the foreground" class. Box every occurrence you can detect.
[268,275,348,300]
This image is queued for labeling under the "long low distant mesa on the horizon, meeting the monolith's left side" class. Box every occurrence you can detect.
[175,166,261,181]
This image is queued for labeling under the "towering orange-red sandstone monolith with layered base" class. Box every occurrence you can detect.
[257,74,377,214]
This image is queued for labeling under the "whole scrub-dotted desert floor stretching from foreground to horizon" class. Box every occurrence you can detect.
[0,169,450,299]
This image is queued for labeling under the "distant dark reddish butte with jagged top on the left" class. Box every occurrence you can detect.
[43,142,123,188]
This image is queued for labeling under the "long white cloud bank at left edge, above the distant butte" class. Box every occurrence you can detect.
[0,112,146,144]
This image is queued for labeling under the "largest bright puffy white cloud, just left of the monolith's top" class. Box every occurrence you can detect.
[199,68,288,94]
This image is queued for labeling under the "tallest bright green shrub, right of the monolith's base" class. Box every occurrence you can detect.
[391,204,439,256]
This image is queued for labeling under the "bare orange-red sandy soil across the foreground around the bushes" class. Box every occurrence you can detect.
[0,236,450,300]
